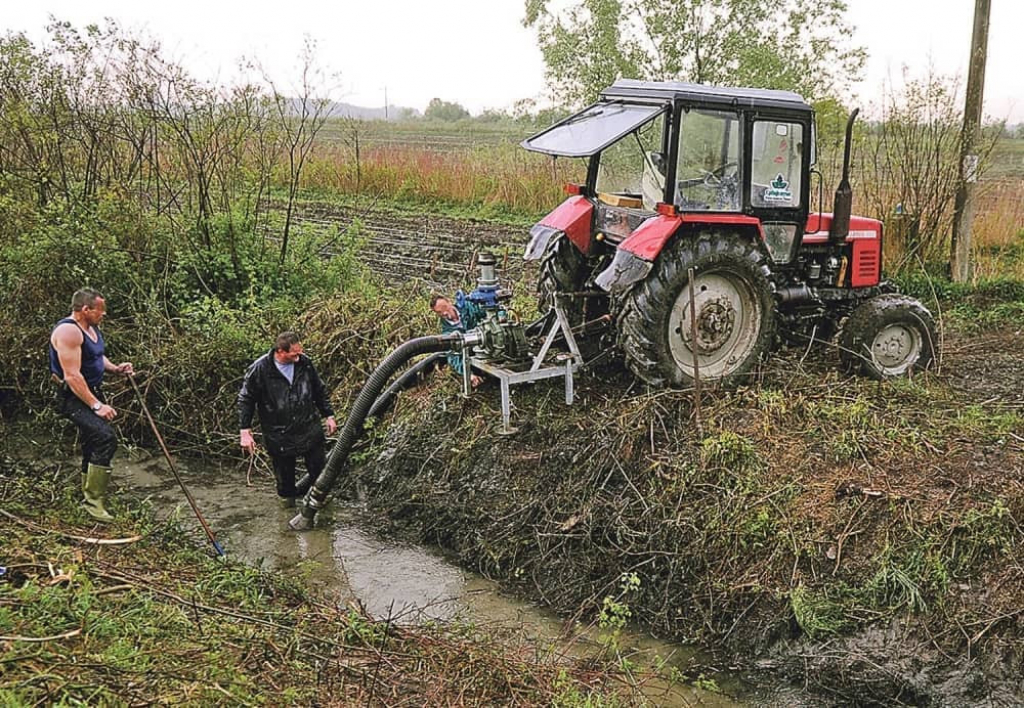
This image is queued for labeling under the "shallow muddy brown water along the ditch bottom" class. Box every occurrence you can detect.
[118,455,757,706]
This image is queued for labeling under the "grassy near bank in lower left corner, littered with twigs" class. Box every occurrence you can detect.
[0,457,620,706]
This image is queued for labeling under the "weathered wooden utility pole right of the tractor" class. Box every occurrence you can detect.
[949,0,991,283]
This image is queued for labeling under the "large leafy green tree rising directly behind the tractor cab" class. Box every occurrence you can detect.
[523,0,866,106]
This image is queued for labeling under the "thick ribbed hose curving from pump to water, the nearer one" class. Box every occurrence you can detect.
[289,332,463,531]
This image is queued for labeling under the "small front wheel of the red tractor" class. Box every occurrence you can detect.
[840,295,938,379]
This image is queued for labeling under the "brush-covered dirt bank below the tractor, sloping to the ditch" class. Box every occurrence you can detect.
[352,323,1024,705]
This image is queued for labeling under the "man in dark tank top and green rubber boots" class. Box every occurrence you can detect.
[49,288,134,522]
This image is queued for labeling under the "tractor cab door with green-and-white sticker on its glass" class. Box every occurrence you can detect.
[744,114,810,263]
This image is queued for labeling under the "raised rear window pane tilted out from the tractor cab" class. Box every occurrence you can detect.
[521,101,668,158]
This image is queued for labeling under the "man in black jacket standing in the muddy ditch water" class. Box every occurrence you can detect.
[239,332,338,506]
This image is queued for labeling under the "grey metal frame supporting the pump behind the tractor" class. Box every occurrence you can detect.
[462,293,583,435]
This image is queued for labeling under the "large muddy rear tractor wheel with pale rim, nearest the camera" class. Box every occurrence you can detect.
[618,232,775,386]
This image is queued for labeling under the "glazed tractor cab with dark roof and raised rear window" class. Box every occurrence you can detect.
[522,80,814,263]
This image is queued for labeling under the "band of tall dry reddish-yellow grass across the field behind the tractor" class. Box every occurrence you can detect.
[294,129,1024,280]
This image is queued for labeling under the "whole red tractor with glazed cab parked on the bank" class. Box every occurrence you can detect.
[522,81,936,386]
